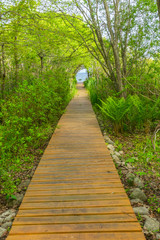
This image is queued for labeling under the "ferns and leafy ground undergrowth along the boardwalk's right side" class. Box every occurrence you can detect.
[85,78,160,240]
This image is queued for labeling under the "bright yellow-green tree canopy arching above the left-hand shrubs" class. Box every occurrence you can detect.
[0,0,88,98]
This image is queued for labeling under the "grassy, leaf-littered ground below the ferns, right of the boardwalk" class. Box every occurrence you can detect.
[110,132,160,217]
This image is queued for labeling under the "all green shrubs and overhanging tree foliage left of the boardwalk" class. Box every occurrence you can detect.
[0,0,90,196]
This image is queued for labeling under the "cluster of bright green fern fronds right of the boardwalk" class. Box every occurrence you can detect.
[99,95,160,134]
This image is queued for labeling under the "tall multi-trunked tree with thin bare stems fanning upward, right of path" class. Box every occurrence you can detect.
[51,0,159,96]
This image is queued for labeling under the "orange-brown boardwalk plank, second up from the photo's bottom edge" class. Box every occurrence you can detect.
[11,222,141,235]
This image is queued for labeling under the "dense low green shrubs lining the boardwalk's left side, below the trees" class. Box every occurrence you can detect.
[0,69,71,195]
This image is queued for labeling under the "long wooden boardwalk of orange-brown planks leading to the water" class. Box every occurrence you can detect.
[7,85,145,240]
